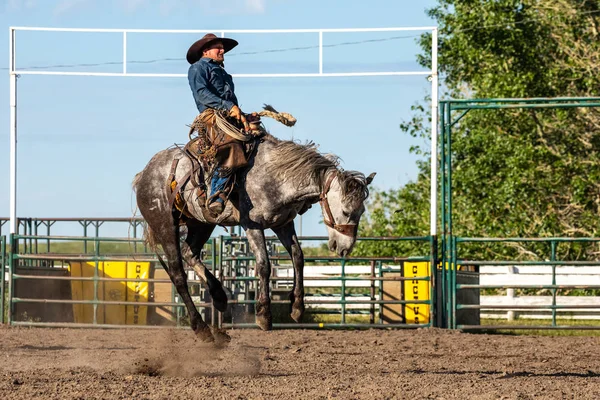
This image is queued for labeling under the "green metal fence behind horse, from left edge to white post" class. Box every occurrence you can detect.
[2,219,435,328]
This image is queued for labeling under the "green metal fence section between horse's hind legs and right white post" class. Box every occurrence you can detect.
[218,236,437,329]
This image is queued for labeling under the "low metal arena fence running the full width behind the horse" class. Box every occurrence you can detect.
[5,219,600,331]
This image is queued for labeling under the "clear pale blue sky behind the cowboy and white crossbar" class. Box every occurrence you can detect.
[0,0,435,235]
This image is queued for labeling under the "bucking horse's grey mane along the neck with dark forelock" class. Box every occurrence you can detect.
[265,135,368,201]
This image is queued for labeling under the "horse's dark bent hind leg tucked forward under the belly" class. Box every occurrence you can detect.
[182,222,227,312]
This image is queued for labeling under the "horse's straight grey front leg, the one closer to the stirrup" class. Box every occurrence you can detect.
[246,229,273,331]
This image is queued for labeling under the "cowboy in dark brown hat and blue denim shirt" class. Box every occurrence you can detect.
[186,33,249,214]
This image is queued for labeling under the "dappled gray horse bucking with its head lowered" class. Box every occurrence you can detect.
[133,134,375,341]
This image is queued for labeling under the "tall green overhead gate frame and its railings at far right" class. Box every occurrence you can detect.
[439,97,600,330]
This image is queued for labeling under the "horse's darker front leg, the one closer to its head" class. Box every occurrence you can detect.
[273,221,304,322]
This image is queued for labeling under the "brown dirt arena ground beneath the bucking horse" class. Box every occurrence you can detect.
[0,327,600,400]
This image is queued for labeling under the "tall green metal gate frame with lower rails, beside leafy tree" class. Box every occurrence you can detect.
[440,97,600,329]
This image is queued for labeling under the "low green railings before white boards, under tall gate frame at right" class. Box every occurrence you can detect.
[446,237,600,330]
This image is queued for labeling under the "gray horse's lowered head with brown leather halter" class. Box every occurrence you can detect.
[320,170,375,257]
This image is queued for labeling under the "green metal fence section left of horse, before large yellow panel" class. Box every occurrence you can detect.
[1,218,215,327]
